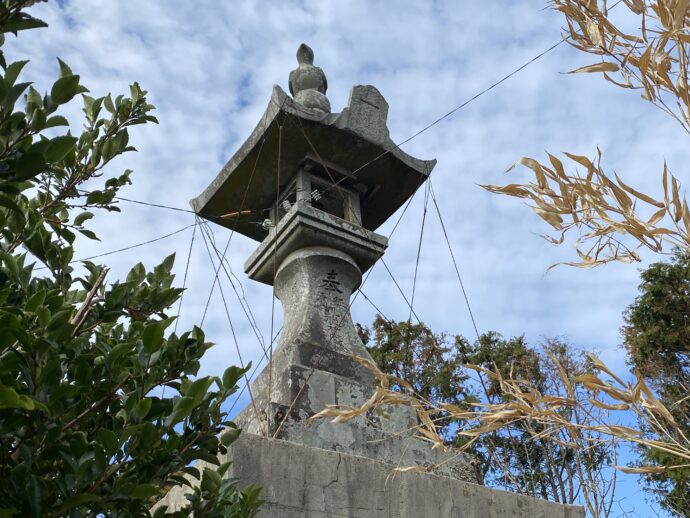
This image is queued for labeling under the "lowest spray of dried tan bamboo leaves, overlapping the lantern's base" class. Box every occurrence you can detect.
[311,328,690,482]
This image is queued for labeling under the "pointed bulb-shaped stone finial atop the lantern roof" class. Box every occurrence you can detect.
[289,43,331,113]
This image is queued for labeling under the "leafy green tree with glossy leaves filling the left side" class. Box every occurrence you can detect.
[0,0,258,517]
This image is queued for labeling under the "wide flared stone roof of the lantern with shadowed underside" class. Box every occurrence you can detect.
[190,86,436,241]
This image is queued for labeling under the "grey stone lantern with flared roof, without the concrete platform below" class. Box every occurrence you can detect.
[191,45,476,481]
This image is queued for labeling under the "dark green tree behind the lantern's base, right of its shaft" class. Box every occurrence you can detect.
[359,316,614,516]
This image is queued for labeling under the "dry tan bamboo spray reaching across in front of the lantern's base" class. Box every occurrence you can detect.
[311,356,690,482]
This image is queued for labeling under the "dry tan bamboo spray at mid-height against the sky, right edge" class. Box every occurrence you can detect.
[482,150,690,268]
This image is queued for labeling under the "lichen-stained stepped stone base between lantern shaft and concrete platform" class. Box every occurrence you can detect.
[235,365,481,483]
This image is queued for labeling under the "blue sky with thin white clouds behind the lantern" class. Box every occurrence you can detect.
[8,0,687,516]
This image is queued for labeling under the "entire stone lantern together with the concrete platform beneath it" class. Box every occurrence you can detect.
[159,45,584,518]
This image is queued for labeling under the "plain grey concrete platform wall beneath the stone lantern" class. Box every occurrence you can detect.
[161,434,585,518]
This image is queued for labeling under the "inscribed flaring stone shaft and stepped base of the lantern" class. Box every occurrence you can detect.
[235,246,481,483]
